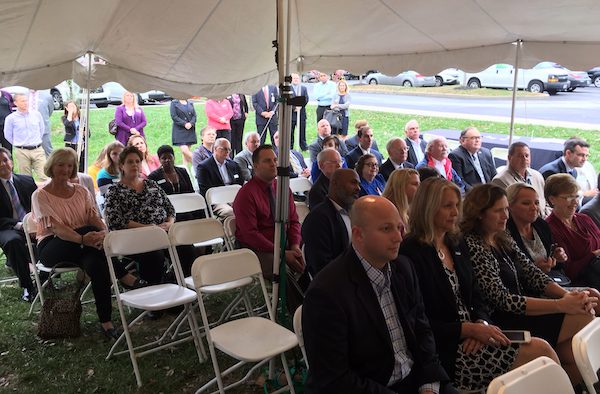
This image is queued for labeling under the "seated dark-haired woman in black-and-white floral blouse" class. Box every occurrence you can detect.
[104,146,175,284]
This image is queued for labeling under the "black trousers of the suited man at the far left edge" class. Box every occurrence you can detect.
[0,229,33,290]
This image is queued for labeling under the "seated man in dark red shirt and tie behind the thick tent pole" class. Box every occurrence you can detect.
[233,145,304,280]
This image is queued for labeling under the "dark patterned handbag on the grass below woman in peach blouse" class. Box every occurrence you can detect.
[38,264,83,339]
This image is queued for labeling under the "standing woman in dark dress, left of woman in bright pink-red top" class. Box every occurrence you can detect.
[170,100,198,167]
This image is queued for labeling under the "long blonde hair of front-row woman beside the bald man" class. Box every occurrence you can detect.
[409,178,461,245]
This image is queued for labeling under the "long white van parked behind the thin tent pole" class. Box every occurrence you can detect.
[466,64,570,94]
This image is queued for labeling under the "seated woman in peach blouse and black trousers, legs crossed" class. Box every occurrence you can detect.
[32,148,145,338]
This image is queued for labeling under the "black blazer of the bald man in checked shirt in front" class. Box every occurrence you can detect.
[302,247,448,394]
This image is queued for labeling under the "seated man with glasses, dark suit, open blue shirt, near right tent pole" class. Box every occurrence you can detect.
[448,127,496,190]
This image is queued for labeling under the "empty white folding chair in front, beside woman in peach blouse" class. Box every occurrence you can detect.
[104,227,206,387]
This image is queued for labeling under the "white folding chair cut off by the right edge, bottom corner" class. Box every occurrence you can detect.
[571,319,600,394]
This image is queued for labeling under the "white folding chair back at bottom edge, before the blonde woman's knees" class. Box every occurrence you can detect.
[487,356,575,394]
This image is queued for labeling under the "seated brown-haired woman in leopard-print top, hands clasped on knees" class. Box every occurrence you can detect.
[461,184,598,384]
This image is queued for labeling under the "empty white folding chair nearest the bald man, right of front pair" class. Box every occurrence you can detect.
[192,249,298,394]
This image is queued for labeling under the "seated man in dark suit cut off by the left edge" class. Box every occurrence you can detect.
[0,147,37,301]
